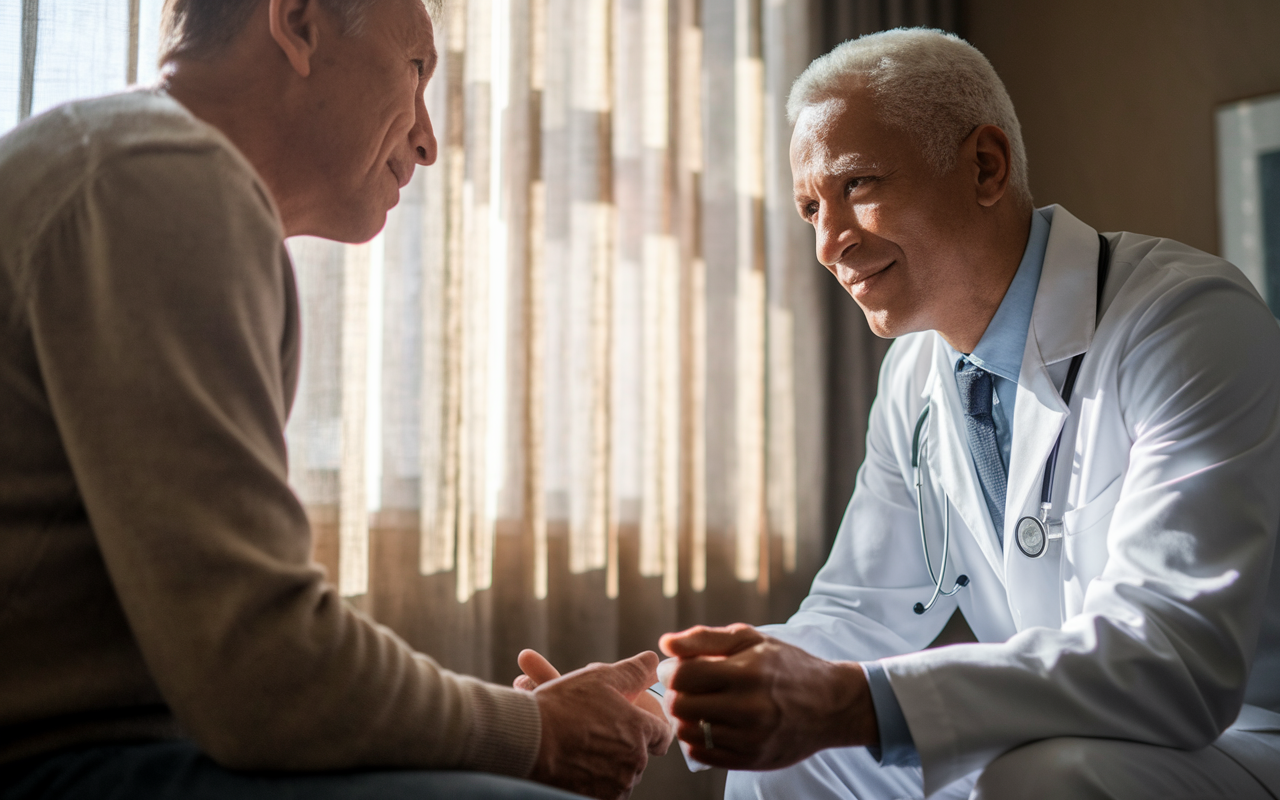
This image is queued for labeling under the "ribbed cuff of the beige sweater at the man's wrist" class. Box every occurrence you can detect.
[460,678,543,778]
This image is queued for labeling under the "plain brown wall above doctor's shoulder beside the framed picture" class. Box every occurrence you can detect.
[964,0,1280,252]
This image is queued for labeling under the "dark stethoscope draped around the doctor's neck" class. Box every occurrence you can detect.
[911,233,1111,614]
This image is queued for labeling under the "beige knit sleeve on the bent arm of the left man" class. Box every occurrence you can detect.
[27,146,540,776]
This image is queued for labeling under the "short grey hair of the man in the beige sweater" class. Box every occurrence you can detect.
[160,0,442,64]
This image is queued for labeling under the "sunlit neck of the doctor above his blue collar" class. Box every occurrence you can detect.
[937,206,1034,353]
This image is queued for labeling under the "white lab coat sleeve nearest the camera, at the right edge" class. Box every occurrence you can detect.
[882,275,1280,792]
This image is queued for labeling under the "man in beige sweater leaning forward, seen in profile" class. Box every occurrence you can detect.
[0,0,671,800]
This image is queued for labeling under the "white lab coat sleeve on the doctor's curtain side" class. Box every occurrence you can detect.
[762,337,956,662]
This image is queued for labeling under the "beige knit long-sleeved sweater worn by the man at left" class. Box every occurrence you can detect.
[0,91,540,776]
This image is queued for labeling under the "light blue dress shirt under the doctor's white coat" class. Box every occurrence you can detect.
[863,209,1053,767]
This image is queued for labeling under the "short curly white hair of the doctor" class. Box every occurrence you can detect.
[787,28,1032,205]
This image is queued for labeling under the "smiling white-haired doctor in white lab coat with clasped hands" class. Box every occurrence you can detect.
[662,29,1280,800]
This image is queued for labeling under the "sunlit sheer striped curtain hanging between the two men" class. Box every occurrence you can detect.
[288,0,826,680]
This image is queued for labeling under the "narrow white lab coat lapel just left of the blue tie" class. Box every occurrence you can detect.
[925,334,1005,581]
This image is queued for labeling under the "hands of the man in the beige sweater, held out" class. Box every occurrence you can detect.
[516,650,672,800]
